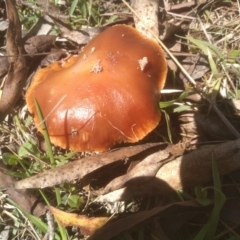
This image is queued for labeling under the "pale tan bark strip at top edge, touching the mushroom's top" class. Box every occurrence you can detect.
[131,0,159,41]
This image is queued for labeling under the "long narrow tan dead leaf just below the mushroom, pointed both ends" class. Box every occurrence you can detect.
[5,143,162,189]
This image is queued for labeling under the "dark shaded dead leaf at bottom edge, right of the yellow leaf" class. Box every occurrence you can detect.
[88,201,202,240]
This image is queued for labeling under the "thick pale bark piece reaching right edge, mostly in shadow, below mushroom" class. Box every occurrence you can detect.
[96,139,240,202]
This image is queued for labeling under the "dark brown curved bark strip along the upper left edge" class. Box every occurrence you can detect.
[0,0,27,120]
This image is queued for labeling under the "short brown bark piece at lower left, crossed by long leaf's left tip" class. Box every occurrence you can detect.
[0,164,46,217]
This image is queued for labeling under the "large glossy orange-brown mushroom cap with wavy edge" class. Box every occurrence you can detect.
[26,25,167,152]
